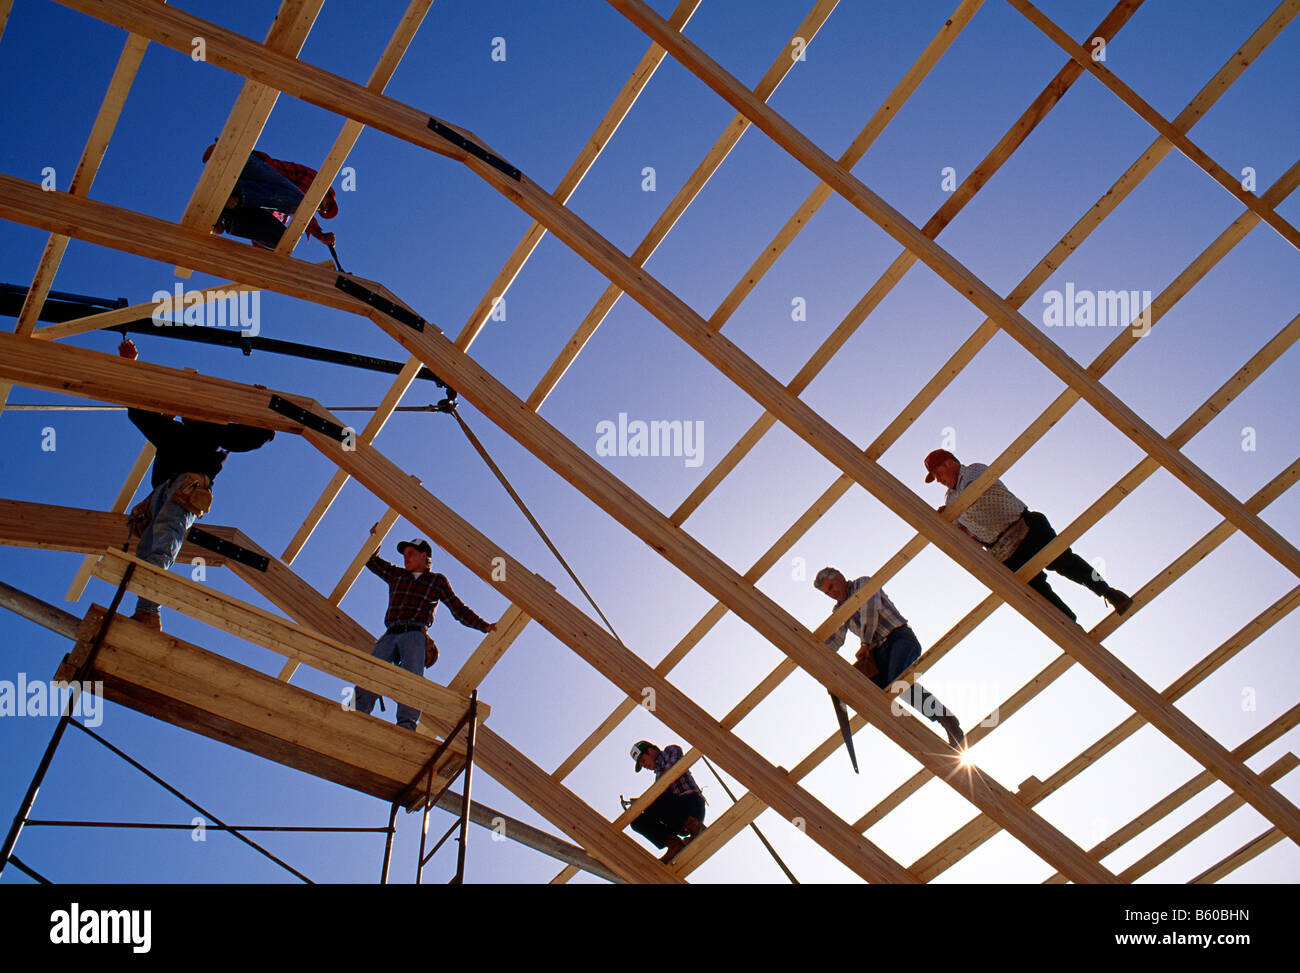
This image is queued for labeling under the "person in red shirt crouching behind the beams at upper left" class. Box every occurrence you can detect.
[203,142,338,250]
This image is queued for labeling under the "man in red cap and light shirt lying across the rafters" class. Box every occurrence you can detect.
[926,449,1134,622]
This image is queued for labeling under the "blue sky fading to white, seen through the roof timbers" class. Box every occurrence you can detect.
[0,0,1300,882]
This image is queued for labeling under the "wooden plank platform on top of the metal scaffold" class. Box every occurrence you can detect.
[55,605,465,810]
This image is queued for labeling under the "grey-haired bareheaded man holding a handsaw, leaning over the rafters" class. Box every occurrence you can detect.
[813,567,966,747]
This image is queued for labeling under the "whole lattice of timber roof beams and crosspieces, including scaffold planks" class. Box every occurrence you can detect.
[0,0,1300,882]
